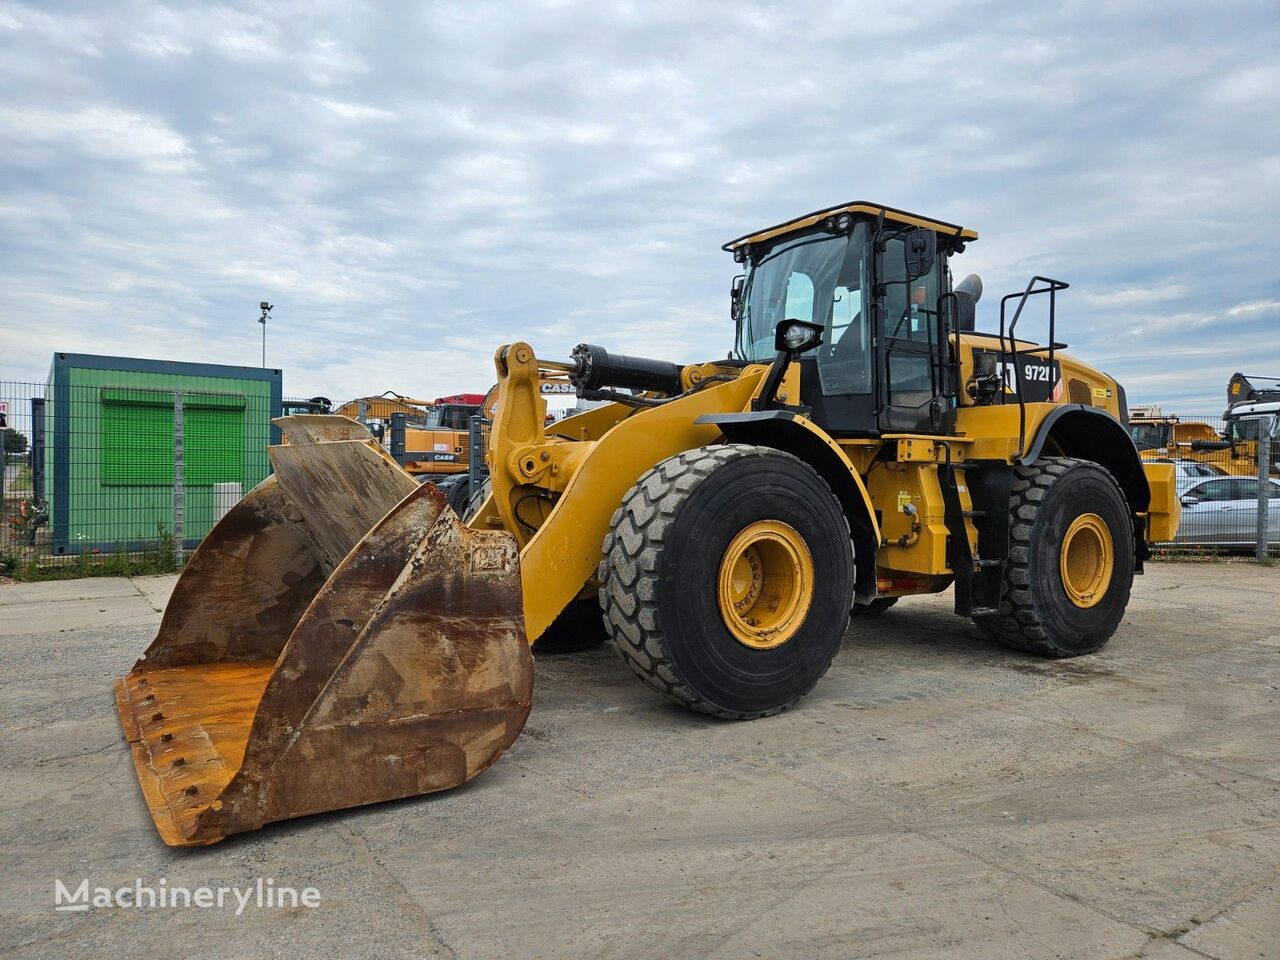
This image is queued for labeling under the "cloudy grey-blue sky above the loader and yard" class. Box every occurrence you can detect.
[0,0,1280,412]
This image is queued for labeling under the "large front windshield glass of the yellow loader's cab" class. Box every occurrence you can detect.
[736,223,867,361]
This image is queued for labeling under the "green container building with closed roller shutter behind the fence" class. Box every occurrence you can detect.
[44,353,280,554]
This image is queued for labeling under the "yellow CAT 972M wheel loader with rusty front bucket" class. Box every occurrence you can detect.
[116,202,1179,846]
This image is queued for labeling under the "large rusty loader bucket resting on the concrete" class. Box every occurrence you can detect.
[115,416,532,846]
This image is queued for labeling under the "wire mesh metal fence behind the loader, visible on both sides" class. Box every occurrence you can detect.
[0,384,1280,575]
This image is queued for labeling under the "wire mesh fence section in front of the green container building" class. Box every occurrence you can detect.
[0,370,291,576]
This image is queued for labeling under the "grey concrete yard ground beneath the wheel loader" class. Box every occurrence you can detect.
[0,563,1280,960]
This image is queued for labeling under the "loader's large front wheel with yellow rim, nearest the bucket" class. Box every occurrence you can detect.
[599,444,854,719]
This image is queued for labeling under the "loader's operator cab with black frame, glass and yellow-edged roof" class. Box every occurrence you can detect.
[724,202,980,436]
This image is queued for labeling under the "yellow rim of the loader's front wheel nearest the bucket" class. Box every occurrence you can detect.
[717,520,813,650]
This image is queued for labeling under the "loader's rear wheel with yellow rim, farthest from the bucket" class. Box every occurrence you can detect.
[974,457,1134,657]
